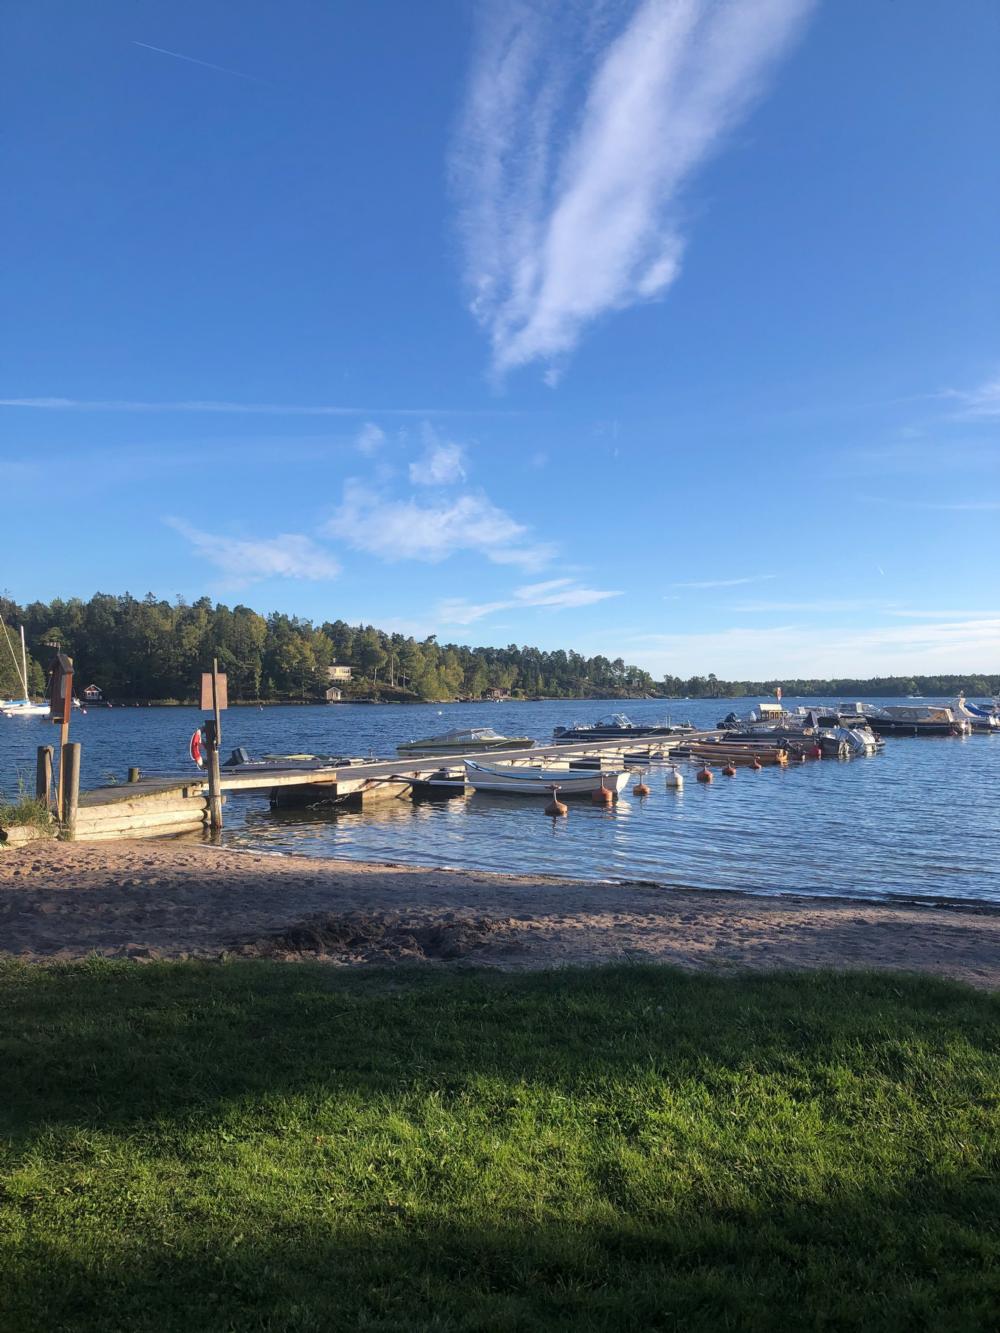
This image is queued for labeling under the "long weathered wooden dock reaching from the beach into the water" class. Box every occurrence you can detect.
[65,733,708,842]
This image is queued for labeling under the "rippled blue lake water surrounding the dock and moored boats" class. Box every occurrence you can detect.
[0,700,1000,902]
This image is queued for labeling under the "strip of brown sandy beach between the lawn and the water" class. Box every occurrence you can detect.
[0,841,1000,988]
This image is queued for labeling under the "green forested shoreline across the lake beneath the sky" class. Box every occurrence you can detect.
[0,593,1000,702]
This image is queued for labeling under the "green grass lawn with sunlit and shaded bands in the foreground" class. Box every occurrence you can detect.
[0,962,1000,1333]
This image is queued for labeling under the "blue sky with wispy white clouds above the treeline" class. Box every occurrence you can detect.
[0,0,1000,677]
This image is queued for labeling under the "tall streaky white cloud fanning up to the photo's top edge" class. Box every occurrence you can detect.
[451,0,812,383]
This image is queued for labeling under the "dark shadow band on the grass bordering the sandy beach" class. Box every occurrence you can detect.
[0,961,1000,1136]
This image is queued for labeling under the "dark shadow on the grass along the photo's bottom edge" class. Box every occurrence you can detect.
[0,1182,1000,1333]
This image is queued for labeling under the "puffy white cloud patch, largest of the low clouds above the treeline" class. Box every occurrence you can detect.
[324,479,555,569]
